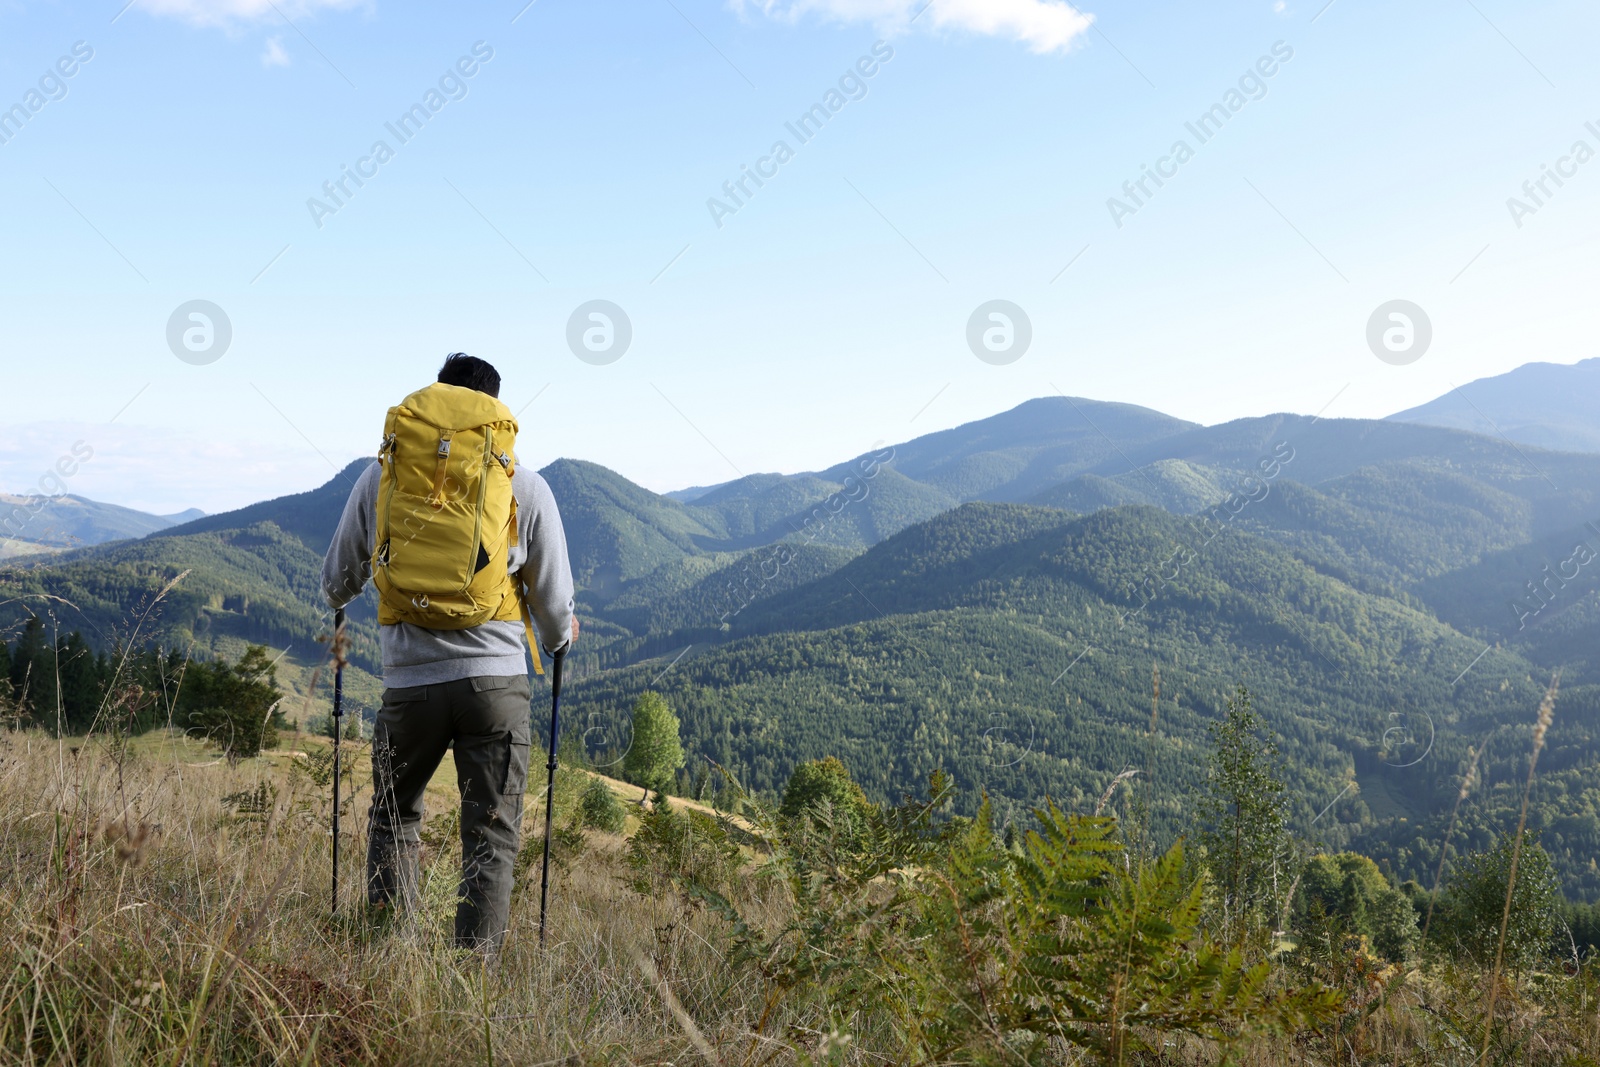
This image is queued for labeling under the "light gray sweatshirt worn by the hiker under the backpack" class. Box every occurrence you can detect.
[322,461,573,689]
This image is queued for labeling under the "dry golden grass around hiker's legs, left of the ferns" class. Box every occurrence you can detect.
[0,733,780,1064]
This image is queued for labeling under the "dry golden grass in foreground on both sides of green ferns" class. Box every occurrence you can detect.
[9,733,1600,1067]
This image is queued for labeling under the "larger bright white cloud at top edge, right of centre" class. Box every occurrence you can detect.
[730,0,1094,53]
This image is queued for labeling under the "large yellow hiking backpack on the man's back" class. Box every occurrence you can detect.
[373,382,544,673]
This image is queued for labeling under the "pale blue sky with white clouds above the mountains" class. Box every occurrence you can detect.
[0,0,1600,512]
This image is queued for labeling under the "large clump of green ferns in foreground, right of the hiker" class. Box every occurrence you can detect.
[634,774,1342,1064]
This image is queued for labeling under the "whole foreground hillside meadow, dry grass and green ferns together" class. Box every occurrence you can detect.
[0,710,1600,1067]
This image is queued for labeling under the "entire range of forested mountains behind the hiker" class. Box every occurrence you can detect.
[0,365,1600,899]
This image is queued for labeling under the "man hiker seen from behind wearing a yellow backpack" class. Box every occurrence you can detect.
[322,352,578,953]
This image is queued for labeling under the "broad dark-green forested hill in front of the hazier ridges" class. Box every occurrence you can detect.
[573,504,1600,894]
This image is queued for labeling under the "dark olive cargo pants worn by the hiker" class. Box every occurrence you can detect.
[366,675,531,952]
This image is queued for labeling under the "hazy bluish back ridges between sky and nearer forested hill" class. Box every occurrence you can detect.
[35,385,1600,648]
